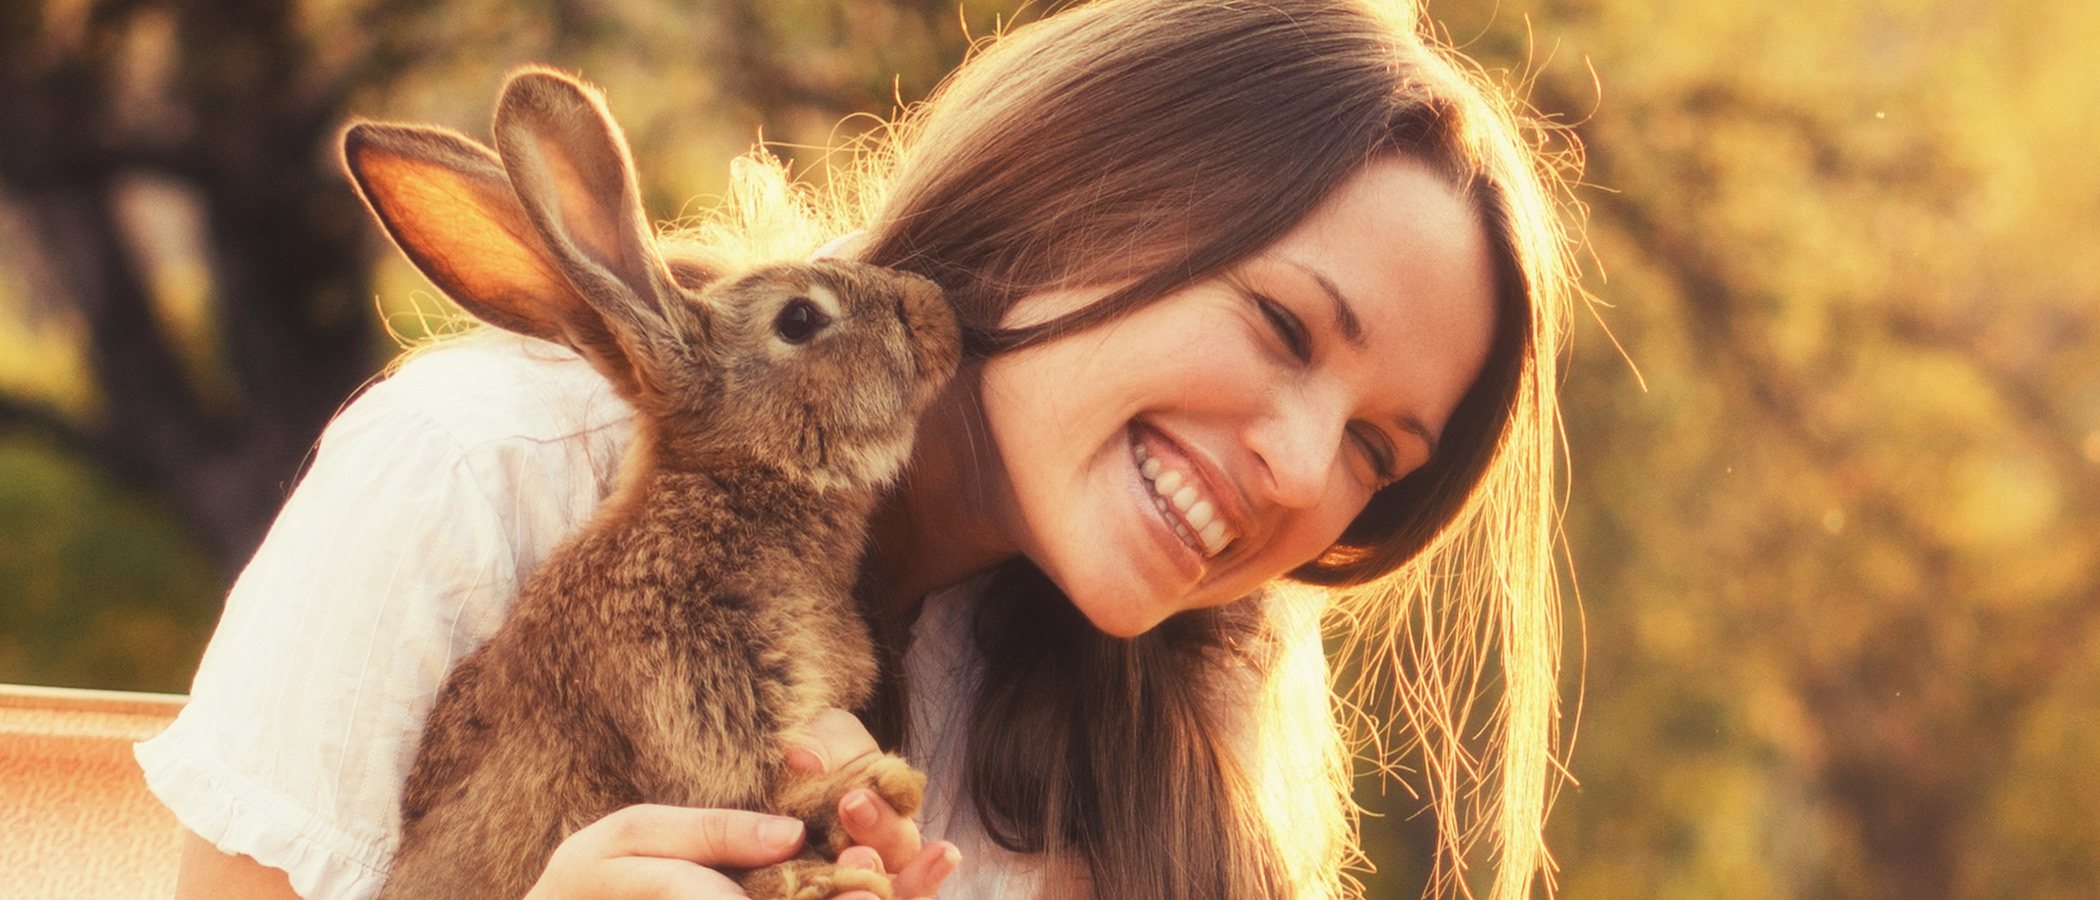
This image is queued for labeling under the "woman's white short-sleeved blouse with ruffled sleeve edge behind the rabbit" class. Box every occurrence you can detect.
[137,334,1331,898]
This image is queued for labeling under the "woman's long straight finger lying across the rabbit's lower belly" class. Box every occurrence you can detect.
[565,803,802,869]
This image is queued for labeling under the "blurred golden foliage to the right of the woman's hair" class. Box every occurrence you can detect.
[1445,0,2100,898]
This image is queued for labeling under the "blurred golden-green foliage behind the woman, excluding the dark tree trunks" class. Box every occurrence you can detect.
[0,0,2100,898]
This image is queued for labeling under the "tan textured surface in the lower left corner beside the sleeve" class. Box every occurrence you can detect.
[0,684,183,898]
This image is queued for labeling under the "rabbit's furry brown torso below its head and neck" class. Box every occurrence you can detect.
[386,466,876,898]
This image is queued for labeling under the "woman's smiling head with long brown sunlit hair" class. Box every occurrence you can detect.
[810,2,1571,898]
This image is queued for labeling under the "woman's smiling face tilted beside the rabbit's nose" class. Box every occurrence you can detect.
[981,157,1495,636]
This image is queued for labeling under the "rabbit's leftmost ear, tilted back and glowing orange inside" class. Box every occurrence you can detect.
[342,122,632,386]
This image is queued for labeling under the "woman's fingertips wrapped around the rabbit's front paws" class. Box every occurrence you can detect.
[788,709,962,898]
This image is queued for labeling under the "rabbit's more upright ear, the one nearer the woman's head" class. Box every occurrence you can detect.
[482,69,680,354]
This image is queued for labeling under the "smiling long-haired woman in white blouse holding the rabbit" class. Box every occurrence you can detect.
[141,0,1571,898]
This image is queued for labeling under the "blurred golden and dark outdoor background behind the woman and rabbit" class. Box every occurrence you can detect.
[0,0,2100,898]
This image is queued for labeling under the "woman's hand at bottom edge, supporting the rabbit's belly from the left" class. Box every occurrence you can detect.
[525,803,880,900]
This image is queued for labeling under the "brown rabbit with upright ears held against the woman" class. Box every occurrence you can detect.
[342,69,958,898]
